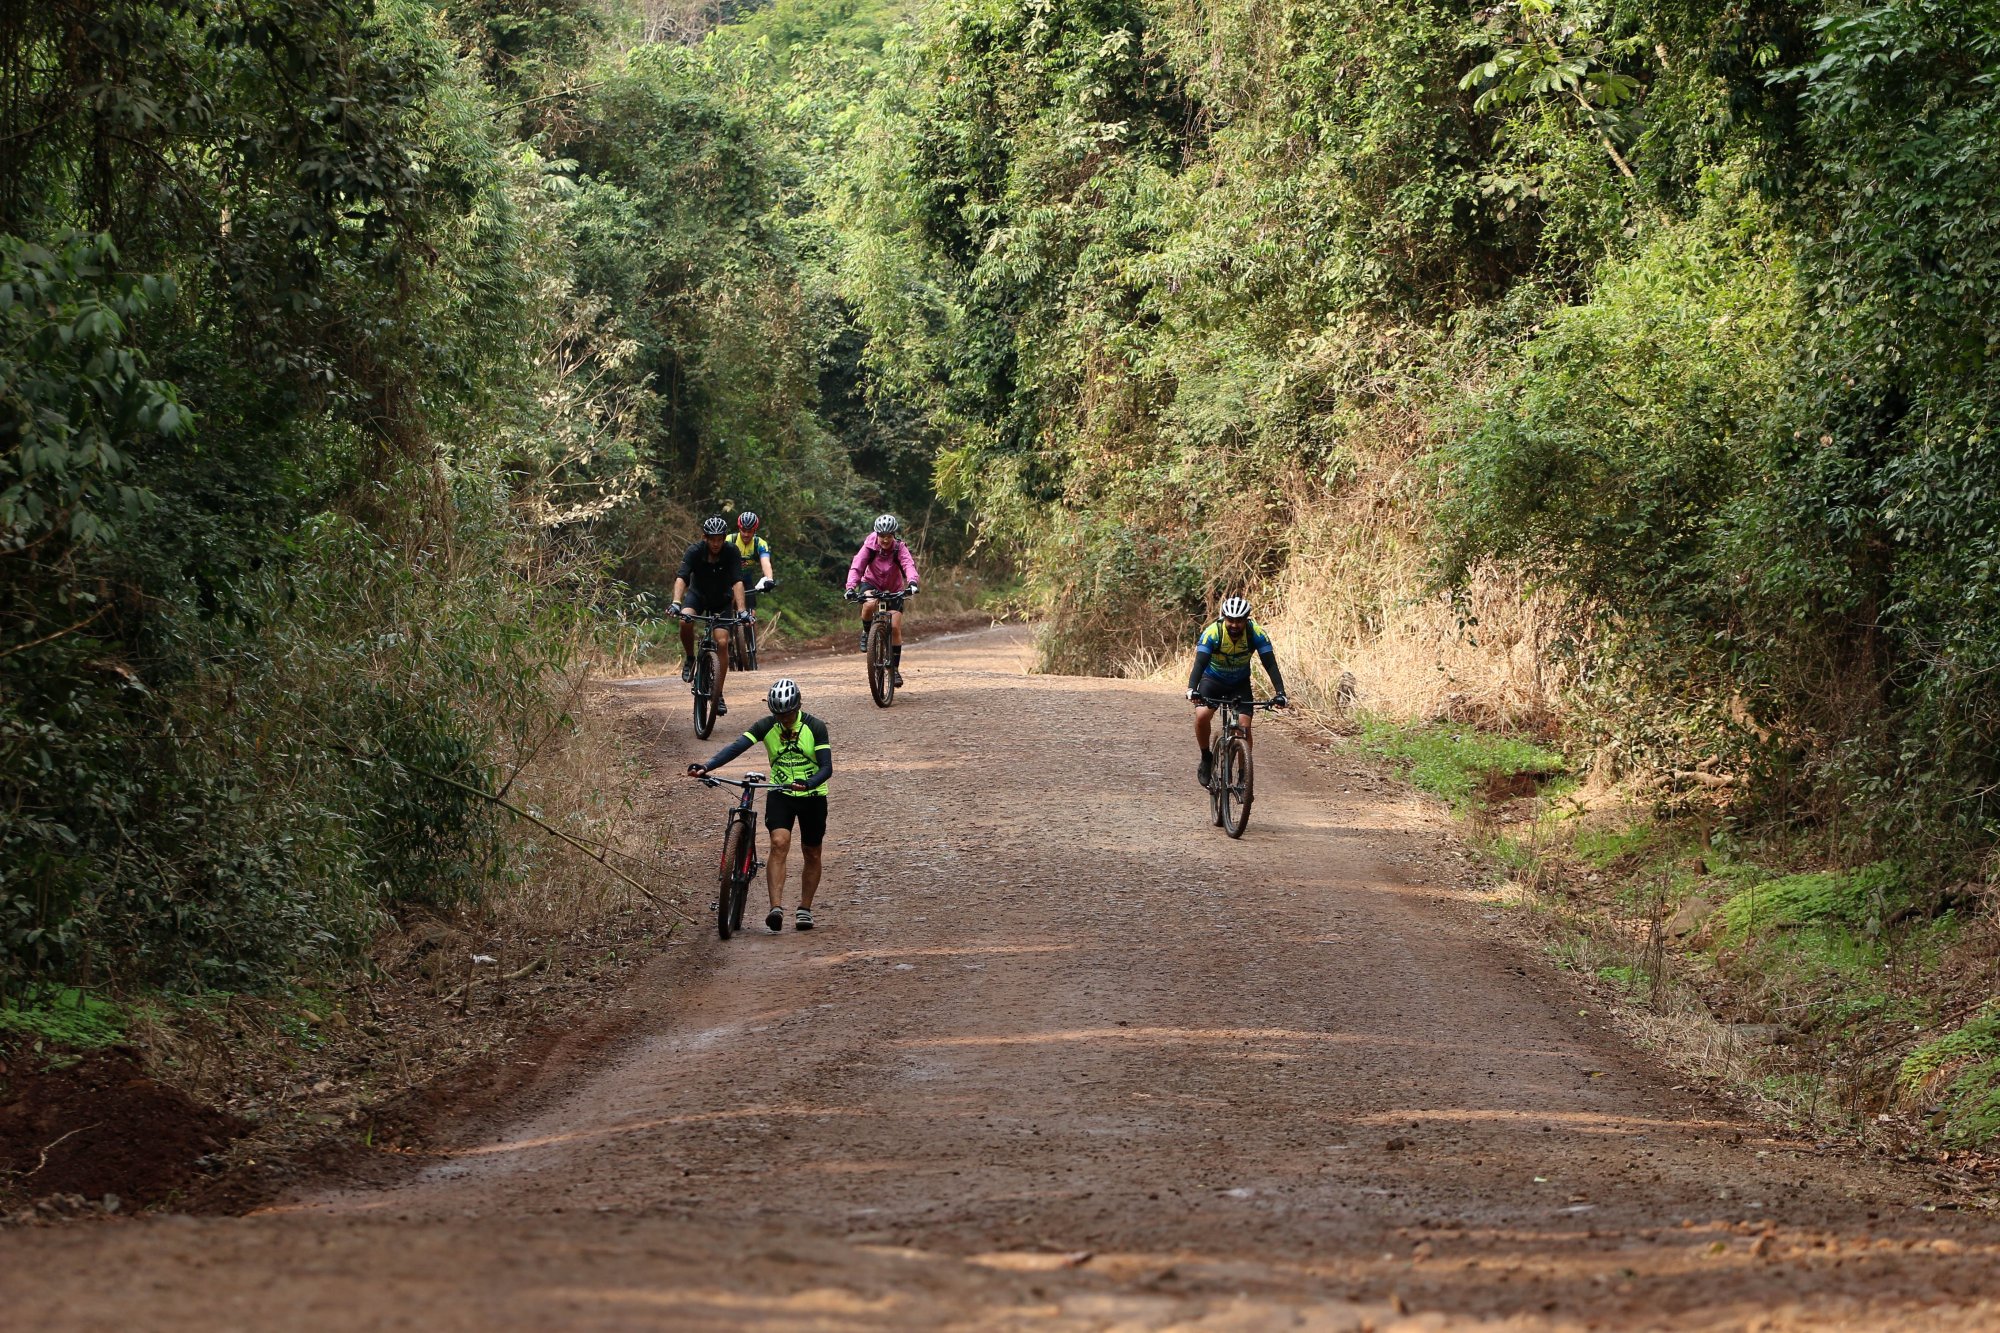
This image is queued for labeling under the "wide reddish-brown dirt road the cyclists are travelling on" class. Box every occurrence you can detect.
[0,630,2000,1329]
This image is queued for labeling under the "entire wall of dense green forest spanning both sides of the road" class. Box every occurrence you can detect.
[11,0,2000,985]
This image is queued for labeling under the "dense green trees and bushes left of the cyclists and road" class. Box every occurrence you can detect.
[0,0,952,995]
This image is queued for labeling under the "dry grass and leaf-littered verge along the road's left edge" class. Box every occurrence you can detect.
[0,685,692,1221]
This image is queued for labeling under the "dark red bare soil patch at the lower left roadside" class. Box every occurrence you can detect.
[0,1053,248,1207]
